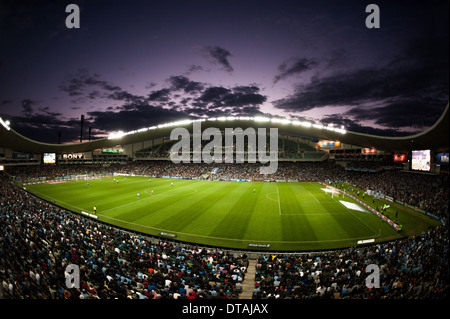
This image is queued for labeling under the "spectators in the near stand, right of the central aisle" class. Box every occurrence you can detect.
[253,226,449,299]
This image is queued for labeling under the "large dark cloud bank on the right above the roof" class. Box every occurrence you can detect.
[273,39,449,132]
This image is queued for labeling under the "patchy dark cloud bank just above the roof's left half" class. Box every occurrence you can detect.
[16,69,267,143]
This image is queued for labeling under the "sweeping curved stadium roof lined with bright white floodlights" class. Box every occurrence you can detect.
[0,103,449,153]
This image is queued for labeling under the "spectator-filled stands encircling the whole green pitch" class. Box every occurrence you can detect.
[0,161,449,299]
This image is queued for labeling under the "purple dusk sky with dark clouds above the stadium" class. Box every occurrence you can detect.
[0,0,449,143]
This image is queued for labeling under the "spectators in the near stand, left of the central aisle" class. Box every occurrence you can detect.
[0,176,248,299]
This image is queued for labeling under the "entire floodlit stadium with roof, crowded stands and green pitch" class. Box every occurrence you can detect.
[0,104,449,299]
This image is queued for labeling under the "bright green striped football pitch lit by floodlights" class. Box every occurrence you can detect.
[22,176,437,251]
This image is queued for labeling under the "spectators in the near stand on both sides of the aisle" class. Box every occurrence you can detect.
[0,165,449,299]
